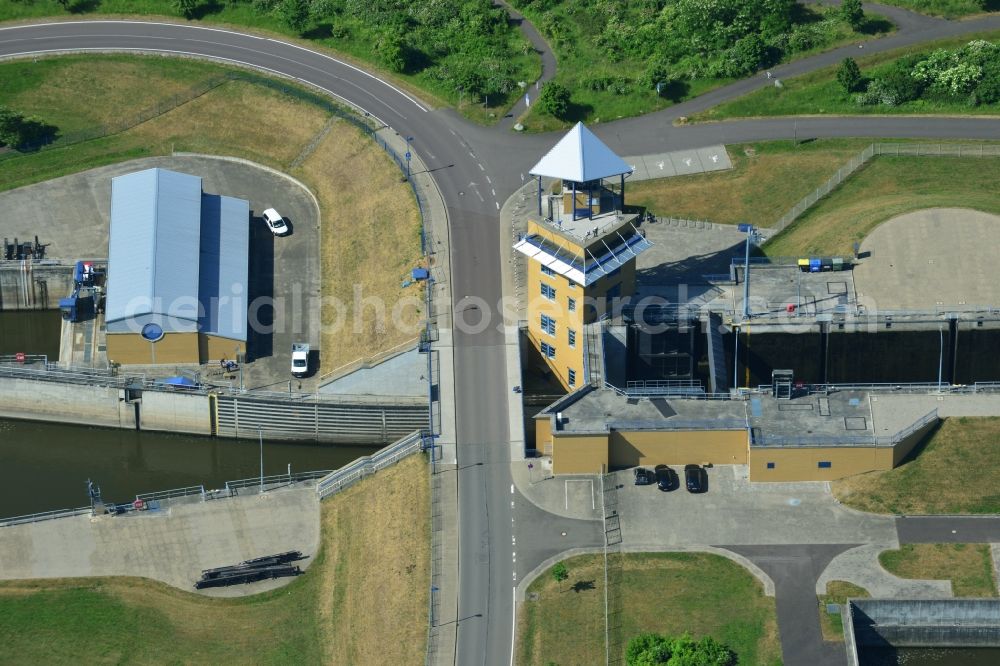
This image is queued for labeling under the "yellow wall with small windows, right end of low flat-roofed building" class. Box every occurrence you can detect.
[750,446,893,481]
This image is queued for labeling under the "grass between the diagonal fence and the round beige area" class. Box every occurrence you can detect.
[763,155,1000,256]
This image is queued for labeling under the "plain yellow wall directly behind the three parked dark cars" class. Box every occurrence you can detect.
[611,430,747,468]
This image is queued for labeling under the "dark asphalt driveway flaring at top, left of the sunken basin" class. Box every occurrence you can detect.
[727,544,850,666]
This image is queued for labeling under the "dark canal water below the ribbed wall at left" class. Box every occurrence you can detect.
[0,419,379,517]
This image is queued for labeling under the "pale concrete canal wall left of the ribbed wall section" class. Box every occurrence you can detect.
[0,377,211,435]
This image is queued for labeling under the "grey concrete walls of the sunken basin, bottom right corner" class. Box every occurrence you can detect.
[849,599,1000,647]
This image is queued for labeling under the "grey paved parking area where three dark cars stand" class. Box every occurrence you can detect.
[615,465,896,548]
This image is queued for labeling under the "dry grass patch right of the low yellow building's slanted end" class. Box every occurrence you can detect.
[833,417,1000,514]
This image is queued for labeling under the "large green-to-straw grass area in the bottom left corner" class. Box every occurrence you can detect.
[0,456,430,664]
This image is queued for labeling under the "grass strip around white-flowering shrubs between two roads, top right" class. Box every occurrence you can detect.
[690,30,1000,121]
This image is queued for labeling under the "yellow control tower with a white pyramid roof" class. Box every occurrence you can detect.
[514,123,651,391]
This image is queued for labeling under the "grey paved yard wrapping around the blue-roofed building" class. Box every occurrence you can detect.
[0,155,321,391]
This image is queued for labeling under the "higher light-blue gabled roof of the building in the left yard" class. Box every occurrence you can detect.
[105,169,201,333]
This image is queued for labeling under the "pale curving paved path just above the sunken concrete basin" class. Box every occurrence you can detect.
[815,543,953,599]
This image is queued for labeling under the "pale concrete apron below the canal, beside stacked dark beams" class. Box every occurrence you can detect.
[0,487,319,597]
